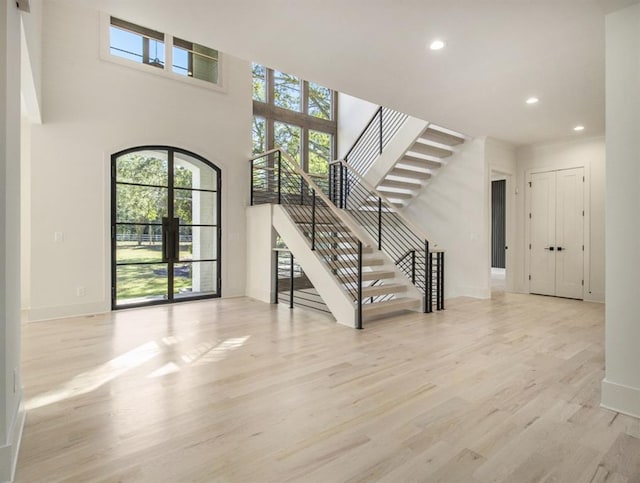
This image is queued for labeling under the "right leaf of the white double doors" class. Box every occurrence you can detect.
[555,168,584,299]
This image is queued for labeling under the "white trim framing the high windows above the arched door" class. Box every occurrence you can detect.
[99,12,227,93]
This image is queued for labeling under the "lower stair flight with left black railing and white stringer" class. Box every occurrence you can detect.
[251,149,426,328]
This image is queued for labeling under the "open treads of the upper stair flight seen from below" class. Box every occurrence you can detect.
[376,124,465,209]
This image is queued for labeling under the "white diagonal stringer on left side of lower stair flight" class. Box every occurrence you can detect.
[272,205,356,328]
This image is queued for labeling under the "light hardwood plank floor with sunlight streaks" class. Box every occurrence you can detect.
[16,294,640,483]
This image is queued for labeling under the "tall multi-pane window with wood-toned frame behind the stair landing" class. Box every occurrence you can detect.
[253,64,337,176]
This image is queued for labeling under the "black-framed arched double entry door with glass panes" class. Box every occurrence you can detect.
[111,146,221,309]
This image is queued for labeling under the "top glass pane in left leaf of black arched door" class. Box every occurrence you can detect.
[116,151,169,186]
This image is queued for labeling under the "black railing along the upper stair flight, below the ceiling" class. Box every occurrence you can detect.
[344,106,409,179]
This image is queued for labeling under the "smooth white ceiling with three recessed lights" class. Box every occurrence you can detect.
[69,0,636,145]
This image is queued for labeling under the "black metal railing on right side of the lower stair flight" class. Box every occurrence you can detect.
[329,160,444,313]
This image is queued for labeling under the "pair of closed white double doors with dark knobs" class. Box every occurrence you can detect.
[529,168,584,299]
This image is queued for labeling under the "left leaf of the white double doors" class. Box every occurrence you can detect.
[529,171,556,295]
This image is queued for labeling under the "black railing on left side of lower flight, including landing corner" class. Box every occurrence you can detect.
[249,148,368,329]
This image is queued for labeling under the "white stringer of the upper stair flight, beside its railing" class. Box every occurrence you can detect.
[362,116,429,190]
